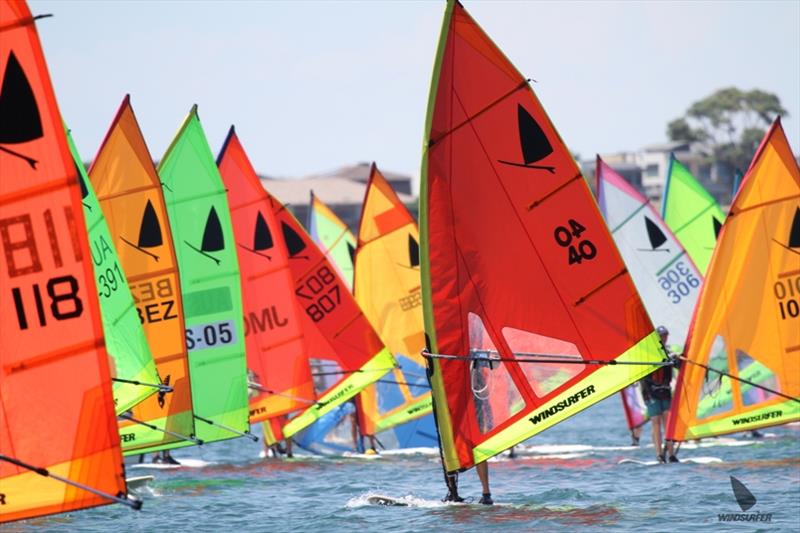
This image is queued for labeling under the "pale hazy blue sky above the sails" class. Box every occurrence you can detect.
[30,0,800,181]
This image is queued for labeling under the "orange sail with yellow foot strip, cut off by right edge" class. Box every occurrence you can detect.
[667,119,800,441]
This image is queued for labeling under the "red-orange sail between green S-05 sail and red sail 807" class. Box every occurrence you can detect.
[217,127,315,423]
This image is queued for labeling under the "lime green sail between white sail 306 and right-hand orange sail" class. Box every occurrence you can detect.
[661,155,725,270]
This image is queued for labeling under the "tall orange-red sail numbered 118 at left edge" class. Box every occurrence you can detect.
[0,1,126,522]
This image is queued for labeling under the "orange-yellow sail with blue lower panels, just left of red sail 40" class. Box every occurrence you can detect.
[353,164,437,448]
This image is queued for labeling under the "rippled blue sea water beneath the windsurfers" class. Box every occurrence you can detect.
[7,397,800,533]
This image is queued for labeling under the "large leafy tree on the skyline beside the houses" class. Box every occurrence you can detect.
[667,87,788,175]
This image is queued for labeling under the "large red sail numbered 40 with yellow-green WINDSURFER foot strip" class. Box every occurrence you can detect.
[420,1,664,477]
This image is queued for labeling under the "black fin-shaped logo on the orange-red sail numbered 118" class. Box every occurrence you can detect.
[0,51,44,169]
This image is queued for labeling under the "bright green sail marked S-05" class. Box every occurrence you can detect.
[158,106,250,445]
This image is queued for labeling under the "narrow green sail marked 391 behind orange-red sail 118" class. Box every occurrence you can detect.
[67,130,161,414]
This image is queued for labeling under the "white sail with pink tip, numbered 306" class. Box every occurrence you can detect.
[595,156,703,429]
